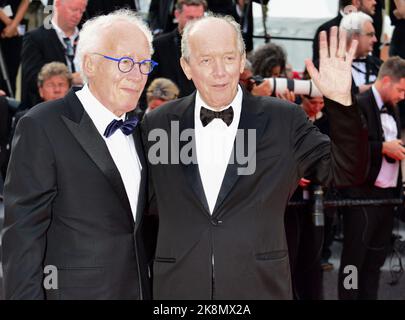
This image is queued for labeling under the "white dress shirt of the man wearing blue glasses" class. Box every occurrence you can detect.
[76,84,142,221]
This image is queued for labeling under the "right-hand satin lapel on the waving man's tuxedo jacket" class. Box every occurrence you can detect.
[213,92,271,216]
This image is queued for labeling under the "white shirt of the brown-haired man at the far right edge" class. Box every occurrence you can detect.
[371,86,399,188]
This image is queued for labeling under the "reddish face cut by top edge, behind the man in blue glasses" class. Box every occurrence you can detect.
[55,0,87,30]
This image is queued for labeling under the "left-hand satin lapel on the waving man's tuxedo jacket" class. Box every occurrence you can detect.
[174,94,211,216]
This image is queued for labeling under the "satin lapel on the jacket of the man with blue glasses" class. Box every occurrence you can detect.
[62,91,134,225]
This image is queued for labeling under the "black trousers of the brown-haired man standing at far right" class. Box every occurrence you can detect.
[338,187,392,300]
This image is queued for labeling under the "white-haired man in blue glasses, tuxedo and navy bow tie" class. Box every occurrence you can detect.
[3,10,156,299]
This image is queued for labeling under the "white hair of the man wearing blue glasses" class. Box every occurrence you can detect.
[76,9,153,82]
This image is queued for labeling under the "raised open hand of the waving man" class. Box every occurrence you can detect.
[305,27,358,106]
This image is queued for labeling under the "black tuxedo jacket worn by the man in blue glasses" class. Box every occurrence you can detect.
[2,91,150,299]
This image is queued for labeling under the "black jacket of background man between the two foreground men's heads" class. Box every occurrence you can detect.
[148,28,195,97]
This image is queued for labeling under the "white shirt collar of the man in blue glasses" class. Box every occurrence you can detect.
[76,84,126,136]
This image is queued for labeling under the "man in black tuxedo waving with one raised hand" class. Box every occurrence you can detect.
[143,16,367,299]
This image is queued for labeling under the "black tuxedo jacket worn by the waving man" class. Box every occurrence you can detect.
[142,93,367,299]
